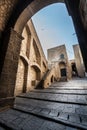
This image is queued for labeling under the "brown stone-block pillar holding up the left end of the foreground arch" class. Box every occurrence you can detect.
[0,29,23,109]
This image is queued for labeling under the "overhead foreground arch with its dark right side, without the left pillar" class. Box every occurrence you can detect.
[7,0,87,69]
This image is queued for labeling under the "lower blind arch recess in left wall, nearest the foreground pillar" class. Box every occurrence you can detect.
[14,56,28,95]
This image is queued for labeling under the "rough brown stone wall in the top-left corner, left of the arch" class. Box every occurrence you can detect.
[0,0,18,74]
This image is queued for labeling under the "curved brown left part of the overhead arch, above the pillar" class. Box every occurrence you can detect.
[9,0,64,33]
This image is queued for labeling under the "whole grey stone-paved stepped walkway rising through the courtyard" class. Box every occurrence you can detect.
[0,78,87,130]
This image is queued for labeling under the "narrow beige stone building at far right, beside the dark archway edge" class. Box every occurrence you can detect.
[73,44,85,77]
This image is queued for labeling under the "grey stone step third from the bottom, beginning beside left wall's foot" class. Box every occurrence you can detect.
[17,92,87,105]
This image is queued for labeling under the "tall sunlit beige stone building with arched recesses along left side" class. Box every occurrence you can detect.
[15,20,48,95]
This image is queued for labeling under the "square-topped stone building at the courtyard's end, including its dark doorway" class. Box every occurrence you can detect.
[48,45,71,80]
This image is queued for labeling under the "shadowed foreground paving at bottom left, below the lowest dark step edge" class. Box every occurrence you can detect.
[0,108,80,130]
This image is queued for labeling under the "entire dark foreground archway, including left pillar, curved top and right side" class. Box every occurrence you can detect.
[0,0,87,107]
